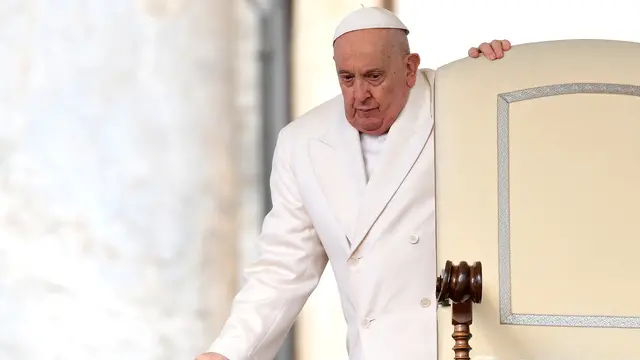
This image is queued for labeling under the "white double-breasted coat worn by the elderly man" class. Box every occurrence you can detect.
[209,70,437,360]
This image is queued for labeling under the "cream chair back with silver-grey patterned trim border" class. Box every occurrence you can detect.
[435,40,640,360]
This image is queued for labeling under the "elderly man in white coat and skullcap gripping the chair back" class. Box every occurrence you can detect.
[197,8,510,360]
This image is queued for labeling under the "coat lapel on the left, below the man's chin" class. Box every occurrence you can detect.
[309,103,367,242]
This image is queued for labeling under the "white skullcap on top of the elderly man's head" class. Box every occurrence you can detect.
[333,7,409,43]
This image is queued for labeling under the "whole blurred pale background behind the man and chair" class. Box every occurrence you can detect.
[0,0,640,360]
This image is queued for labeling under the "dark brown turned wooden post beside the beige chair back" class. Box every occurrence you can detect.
[436,260,482,360]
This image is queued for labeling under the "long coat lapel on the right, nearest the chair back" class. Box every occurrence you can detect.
[351,72,433,252]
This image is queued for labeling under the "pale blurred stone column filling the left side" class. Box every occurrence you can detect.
[0,0,252,360]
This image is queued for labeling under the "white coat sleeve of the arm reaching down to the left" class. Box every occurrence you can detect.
[209,128,327,360]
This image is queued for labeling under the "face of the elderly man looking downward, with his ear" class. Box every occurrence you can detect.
[334,29,420,135]
